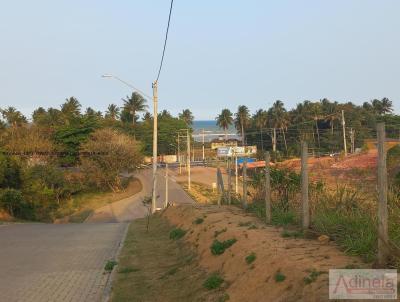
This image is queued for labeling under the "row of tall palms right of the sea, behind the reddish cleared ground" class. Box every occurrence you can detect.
[216,98,400,156]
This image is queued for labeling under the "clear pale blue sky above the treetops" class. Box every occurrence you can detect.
[0,0,400,120]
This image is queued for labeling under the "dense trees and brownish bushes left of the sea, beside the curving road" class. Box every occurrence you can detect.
[0,93,193,221]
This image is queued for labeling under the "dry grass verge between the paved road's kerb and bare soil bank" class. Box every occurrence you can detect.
[111,214,223,302]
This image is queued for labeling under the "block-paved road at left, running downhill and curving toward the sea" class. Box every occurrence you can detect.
[0,170,193,302]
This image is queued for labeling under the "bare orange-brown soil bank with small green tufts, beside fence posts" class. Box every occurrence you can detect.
[164,205,365,302]
